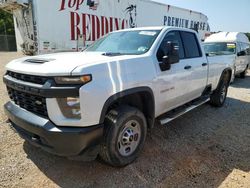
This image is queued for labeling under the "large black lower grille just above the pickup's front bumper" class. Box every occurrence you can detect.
[7,87,48,117]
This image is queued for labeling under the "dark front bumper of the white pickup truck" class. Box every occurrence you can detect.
[4,102,103,158]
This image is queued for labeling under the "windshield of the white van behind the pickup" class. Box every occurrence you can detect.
[204,42,236,55]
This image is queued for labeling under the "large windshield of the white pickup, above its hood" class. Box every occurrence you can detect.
[85,30,160,55]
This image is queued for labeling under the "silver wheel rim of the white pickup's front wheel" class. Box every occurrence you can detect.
[117,120,141,157]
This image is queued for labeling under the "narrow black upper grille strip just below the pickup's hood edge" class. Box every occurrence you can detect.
[6,71,49,85]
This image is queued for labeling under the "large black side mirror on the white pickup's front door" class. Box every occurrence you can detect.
[160,42,180,71]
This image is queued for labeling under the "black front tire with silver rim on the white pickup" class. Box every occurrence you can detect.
[99,106,147,167]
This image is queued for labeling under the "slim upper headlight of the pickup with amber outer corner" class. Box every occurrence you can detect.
[55,75,92,84]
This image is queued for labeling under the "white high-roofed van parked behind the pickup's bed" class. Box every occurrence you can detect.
[204,32,250,78]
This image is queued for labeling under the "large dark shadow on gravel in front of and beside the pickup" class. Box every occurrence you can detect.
[24,95,250,188]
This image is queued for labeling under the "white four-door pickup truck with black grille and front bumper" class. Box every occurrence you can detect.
[3,27,232,166]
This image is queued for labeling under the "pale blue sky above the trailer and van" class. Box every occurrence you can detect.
[154,0,250,32]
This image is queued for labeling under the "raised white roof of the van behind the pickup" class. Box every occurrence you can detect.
[205,32,249,43]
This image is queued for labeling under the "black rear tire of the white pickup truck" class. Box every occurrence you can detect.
[210,72,230,107]
